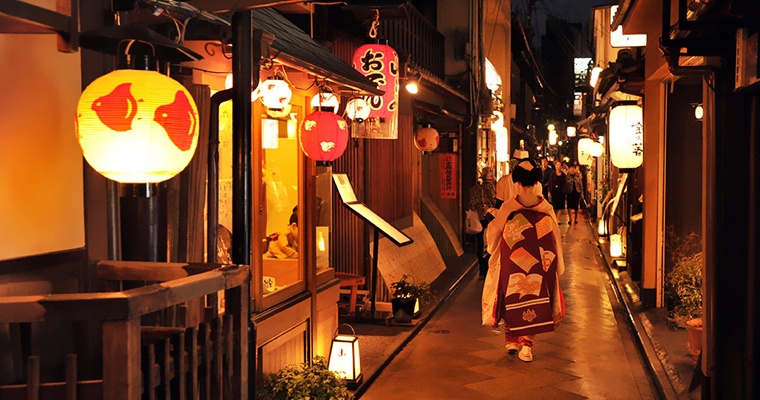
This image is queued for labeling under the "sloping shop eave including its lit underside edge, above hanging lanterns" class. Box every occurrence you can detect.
[251,8,384,96]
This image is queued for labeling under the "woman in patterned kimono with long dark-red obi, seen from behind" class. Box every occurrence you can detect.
[482,159,565,362]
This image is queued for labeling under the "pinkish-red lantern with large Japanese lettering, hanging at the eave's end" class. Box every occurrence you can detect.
[353,43,399,118]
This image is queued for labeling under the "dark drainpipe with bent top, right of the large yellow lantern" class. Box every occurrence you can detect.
[206,89,232,263]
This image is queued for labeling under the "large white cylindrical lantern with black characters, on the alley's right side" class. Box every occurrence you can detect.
[609,105,644,169]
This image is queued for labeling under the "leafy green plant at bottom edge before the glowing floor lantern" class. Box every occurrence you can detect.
[258,356,354,400]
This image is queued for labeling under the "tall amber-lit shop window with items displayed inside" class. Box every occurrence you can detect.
[254,106,300,297]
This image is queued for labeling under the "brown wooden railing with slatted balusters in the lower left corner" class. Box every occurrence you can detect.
[0,261,250,400]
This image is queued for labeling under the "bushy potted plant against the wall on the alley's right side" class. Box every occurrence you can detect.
[665,252,702,365]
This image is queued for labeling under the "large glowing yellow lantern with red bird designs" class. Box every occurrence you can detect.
[76,69,198,183]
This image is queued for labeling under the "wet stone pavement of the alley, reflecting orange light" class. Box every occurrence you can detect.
[361,217,655,400]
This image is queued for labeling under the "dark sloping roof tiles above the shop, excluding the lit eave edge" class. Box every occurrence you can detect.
[252,7,381,93]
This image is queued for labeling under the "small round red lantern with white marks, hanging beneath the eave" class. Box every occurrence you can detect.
[298,111,348,162]
